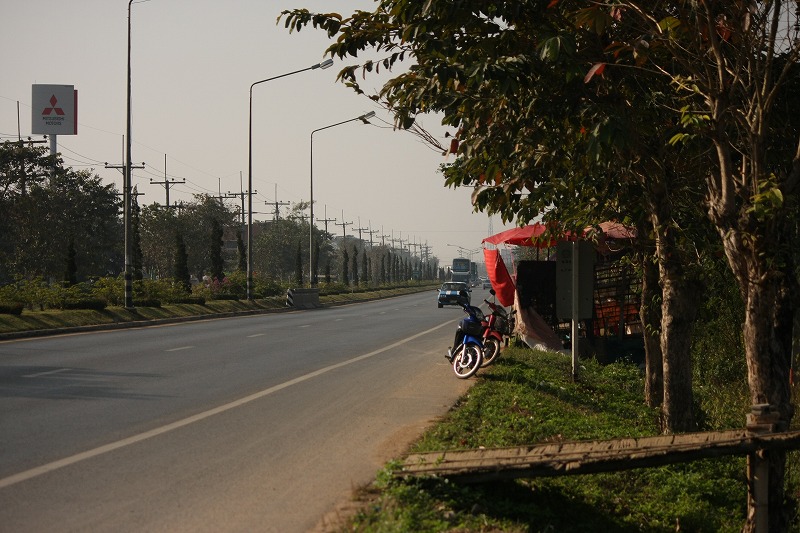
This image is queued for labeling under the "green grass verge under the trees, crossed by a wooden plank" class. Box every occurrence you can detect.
[341,348,800,533]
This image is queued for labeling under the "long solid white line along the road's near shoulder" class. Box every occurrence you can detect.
[0,320,453,489]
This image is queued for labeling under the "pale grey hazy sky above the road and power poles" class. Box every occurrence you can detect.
[0,0,508,265]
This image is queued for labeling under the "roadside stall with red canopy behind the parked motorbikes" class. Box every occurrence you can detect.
[482,222,644,362]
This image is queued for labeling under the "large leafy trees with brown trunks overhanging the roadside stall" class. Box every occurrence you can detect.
[283,0,800,527]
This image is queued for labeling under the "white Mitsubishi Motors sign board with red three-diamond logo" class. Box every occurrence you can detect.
[31,85,78,135]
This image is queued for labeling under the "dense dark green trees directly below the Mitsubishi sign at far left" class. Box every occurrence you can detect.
[0,142,121,283]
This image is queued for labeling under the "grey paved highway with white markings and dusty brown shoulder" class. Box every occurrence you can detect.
[0,291,482,532]
